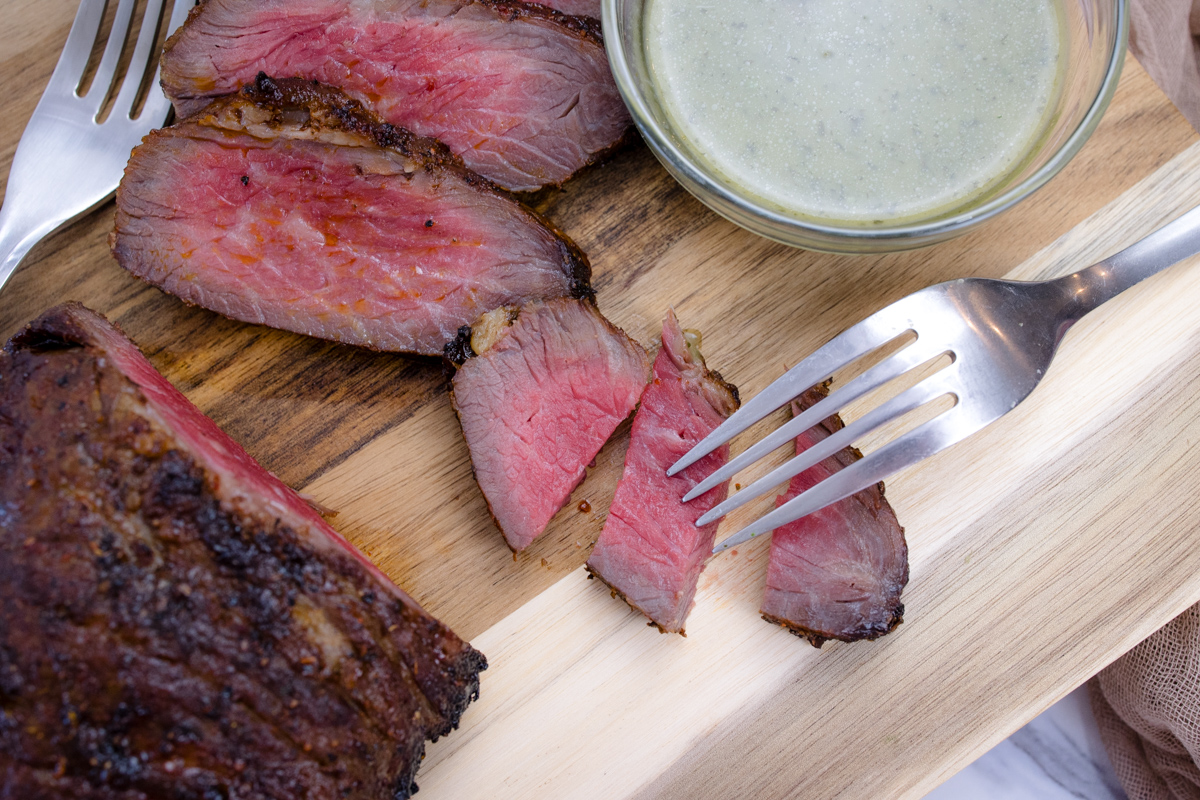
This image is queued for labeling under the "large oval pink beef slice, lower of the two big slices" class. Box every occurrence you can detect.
[112,77,592,355]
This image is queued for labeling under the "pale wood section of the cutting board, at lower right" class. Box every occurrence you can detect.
[421,145,1200,800]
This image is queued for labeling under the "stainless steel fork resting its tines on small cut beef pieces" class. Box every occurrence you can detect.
[667,200,1200,554]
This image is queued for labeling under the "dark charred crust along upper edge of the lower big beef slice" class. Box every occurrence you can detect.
[220,75,595,300]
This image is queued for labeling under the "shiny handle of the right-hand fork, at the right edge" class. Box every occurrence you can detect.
[1057,206,1200,321]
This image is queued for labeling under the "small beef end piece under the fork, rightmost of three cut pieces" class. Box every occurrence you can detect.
[760,386,908,648]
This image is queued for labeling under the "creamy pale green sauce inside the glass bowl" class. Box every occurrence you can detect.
[644,0,1062,223]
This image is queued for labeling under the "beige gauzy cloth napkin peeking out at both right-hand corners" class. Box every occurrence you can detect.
[1088,0,1200,800]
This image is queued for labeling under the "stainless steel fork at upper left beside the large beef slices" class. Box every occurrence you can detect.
[0,0,192,288]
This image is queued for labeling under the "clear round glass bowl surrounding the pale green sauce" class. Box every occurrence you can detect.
[602,0,1129,253]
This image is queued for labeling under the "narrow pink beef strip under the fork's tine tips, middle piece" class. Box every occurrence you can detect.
[588,312,738,633]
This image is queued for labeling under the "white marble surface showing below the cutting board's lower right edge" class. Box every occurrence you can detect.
[925,686,1127,800]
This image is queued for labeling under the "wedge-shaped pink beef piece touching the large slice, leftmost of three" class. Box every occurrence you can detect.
[446,300,650,551]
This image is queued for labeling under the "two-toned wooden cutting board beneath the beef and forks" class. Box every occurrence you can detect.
[0,0,1200,800]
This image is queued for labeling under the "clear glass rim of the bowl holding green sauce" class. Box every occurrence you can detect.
[601,0,1129,249]
